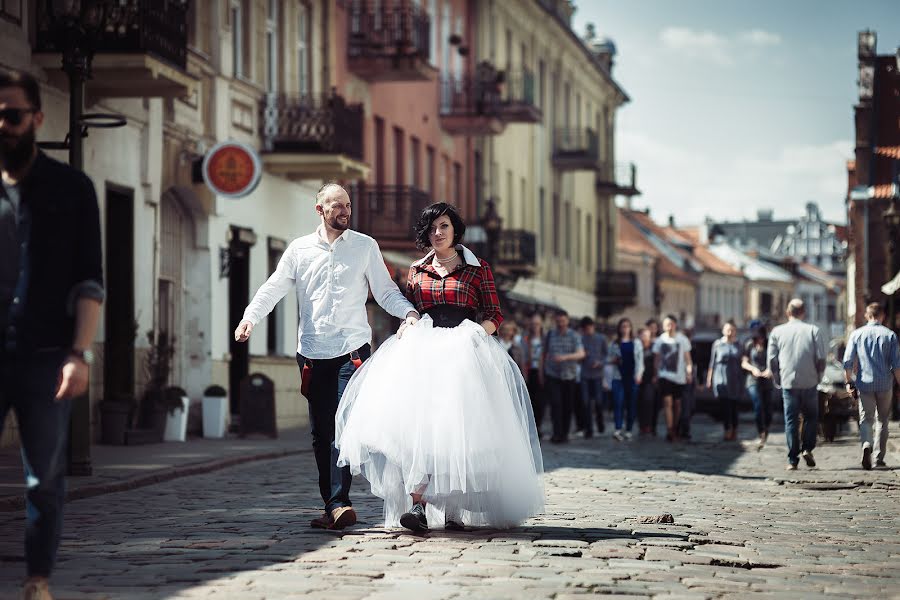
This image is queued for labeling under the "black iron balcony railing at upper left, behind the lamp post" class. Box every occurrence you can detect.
[35,0,188,69]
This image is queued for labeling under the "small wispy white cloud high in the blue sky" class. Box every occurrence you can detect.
[659,27,781,67]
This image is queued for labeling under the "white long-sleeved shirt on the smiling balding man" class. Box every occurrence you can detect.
[244,225,415,359]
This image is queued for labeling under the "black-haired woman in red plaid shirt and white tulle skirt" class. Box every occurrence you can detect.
[335,202,544,532]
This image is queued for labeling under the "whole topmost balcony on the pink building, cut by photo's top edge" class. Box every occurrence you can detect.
[347,0,436,82]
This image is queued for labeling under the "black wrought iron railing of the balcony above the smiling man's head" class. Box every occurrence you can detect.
[260,93,363,160]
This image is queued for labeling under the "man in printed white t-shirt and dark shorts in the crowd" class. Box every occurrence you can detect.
[653,315,694,442]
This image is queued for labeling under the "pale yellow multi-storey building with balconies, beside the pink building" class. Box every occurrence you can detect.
[475,0,634,316]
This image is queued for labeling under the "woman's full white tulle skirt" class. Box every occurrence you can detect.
[335,315,544,528]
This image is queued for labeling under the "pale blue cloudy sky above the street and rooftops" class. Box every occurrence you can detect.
[572,0,900,225]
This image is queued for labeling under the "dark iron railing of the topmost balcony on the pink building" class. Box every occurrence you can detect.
[347,0,431,77]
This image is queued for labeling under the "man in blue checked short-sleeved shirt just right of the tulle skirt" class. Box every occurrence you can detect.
[544,309,584,444]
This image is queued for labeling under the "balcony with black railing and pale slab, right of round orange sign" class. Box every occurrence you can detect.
[260,93,369,179]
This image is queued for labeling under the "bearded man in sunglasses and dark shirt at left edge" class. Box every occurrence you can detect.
[0,72,104,600]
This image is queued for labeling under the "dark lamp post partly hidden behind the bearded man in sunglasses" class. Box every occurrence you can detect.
[43,0,110,476]
